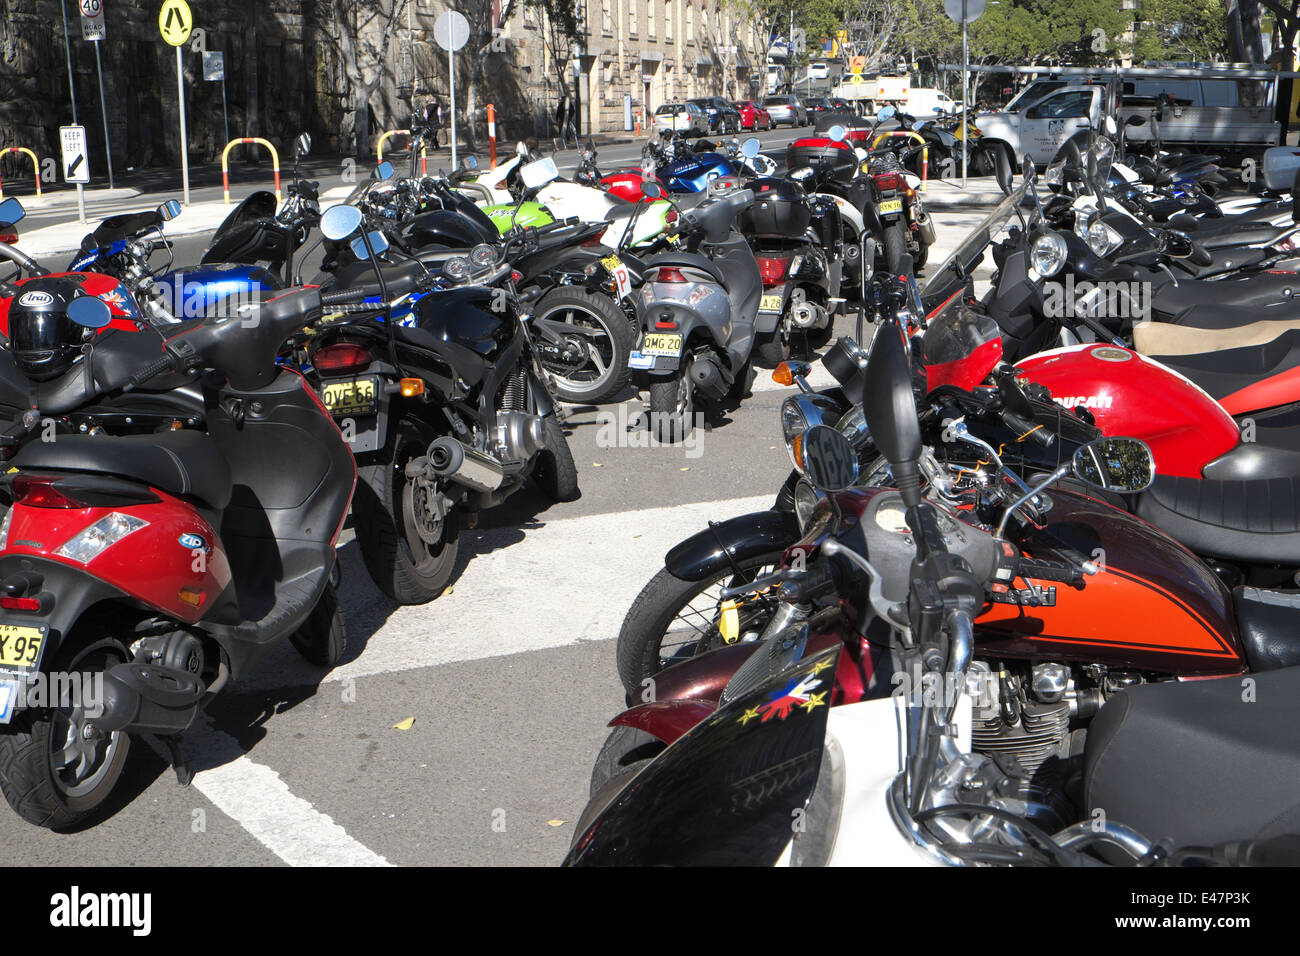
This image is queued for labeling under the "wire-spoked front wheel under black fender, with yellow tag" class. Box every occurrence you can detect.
[615,551,784,702]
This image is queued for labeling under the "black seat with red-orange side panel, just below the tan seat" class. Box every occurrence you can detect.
[1151,326,1300,415]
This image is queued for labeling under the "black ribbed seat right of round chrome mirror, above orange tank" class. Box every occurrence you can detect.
[1138,475,1300,567]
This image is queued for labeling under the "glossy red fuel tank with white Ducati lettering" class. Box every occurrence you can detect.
[1015,345,1240,479]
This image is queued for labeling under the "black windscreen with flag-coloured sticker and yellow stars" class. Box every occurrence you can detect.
[564,645,840,866]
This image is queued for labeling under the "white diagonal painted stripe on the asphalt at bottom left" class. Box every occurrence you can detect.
[151,717,393,866]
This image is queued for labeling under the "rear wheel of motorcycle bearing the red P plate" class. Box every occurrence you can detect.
[533,286,636,405]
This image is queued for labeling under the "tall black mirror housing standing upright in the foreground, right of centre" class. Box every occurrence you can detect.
[862,323,920,507]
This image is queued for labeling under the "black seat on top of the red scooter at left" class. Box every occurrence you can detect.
[10,431,230,511]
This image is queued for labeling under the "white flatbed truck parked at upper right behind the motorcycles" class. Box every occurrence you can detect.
[975,77,1282,165]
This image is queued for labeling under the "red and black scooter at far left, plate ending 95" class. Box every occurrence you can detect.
[0,277,356,829]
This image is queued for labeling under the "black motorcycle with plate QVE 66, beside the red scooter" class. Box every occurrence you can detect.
[307,206,579,604]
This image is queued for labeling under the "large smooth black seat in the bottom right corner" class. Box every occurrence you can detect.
[1082,667,1300,847]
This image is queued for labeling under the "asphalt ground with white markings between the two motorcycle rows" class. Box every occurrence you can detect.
[0,123,983,866]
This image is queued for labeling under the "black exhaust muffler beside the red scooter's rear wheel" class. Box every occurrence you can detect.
[86,661,205,736]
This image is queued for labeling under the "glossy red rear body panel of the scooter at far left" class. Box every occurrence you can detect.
[3,475,230,624]
